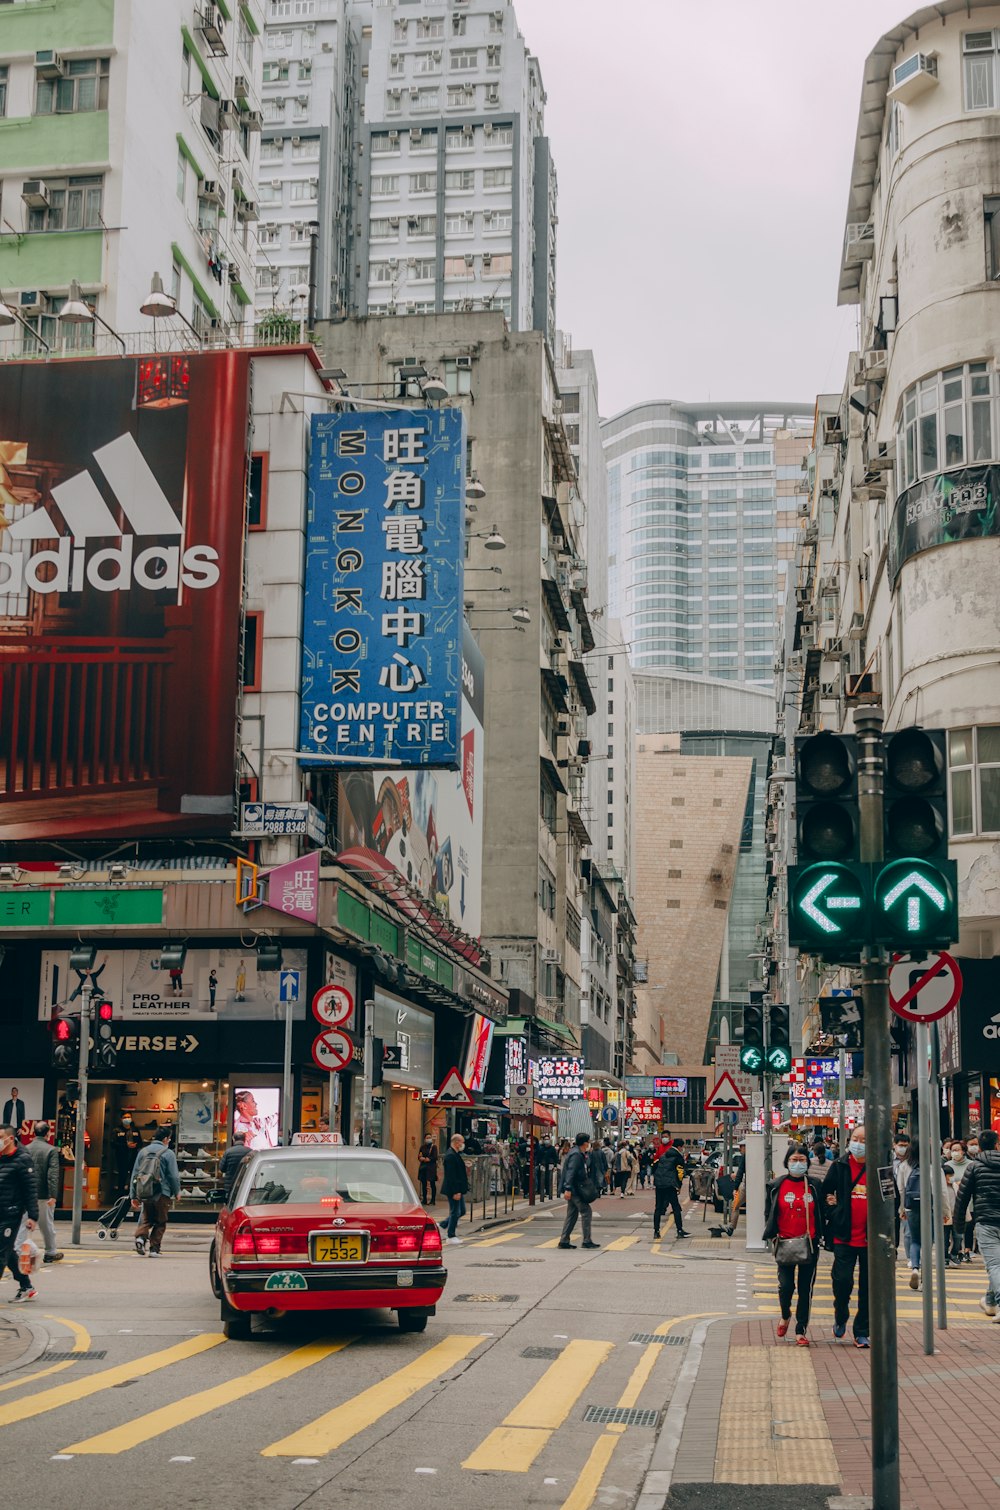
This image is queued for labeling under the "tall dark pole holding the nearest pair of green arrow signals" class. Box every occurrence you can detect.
[853,704,899,1510]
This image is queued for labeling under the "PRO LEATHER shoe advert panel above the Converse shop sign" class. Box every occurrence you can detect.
[38,948,307,1022]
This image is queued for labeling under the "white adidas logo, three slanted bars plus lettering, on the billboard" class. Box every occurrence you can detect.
[0,435,219,593]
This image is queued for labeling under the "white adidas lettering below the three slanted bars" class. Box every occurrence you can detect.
[0,536,219,593]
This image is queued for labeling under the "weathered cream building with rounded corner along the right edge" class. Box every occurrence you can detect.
[785,0,1000,1133]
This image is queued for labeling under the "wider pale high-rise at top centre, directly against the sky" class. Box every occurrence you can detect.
[352,0,556,336]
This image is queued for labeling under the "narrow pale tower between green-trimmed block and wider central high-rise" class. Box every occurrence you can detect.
[255,0,358,325]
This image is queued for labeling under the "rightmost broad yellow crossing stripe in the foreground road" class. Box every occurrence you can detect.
[462,1341,615,1474]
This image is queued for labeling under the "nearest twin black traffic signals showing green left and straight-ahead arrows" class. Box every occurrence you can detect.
[789,728,958,960]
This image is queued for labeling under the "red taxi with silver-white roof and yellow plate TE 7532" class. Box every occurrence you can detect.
[210,1145,447,1338]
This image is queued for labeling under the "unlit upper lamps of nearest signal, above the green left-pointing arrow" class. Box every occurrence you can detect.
[795,732,861,865]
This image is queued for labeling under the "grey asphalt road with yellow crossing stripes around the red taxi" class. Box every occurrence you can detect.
[0,1211,736,1510]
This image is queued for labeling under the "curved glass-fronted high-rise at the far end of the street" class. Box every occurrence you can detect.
[601,402,811,686]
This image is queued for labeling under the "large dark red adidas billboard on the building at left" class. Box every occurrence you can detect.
[0,350,250,843]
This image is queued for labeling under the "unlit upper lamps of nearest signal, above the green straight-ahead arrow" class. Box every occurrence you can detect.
[884,728,949,861]
